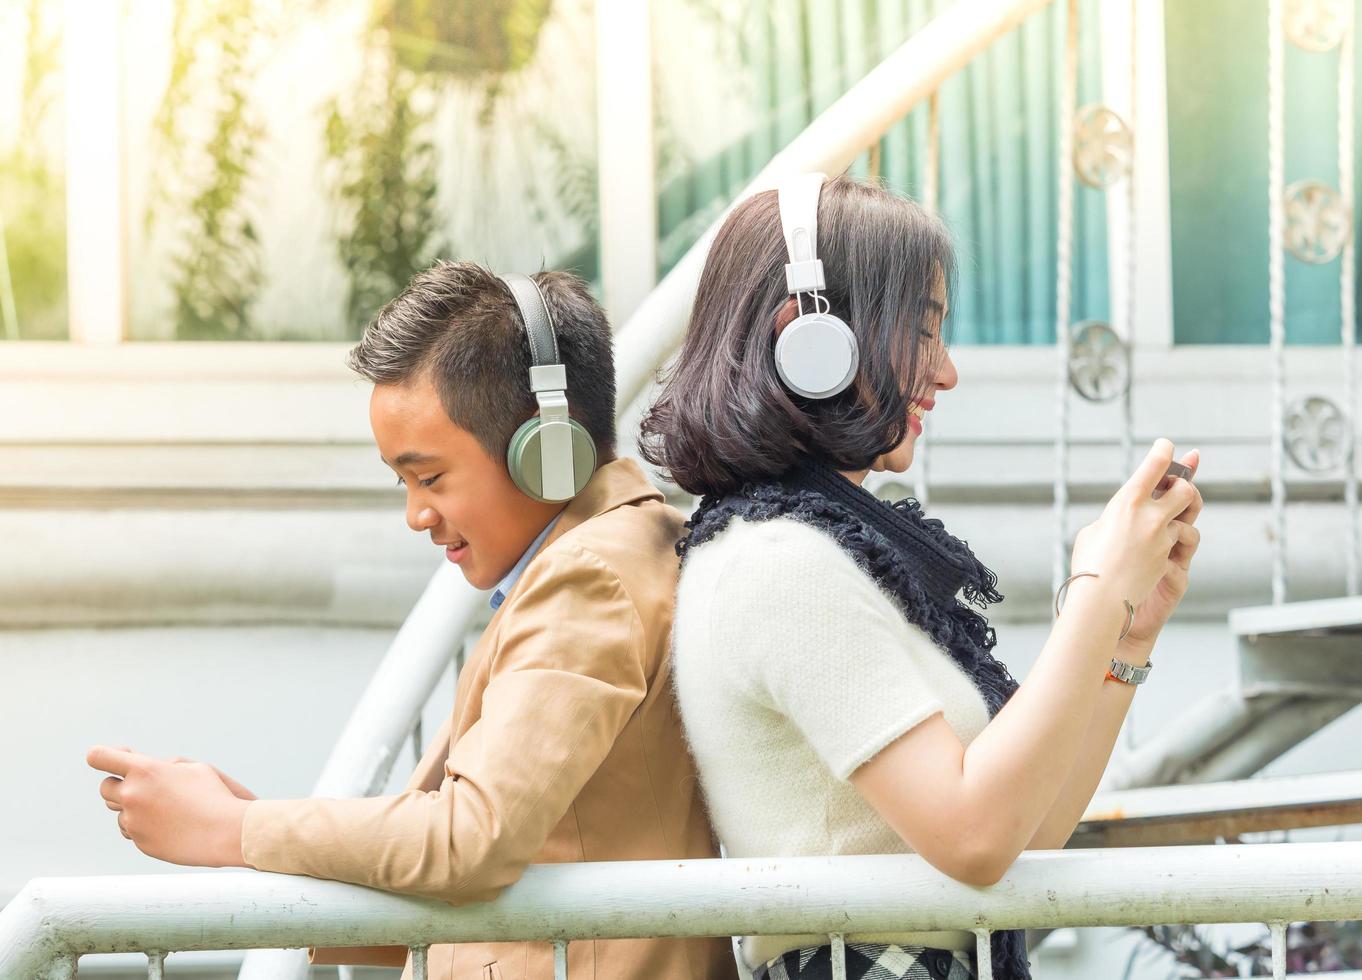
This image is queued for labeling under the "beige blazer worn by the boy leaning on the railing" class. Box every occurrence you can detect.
[241,460,735,980]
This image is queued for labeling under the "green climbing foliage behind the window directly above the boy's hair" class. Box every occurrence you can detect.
[326,50,445,336]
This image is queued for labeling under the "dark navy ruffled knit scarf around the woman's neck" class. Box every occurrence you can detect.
[677,460,1031,980]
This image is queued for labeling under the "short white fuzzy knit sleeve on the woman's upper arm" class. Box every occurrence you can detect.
[711,519,945,780]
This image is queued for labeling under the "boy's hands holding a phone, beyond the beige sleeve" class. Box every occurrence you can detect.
[86,746,255,867]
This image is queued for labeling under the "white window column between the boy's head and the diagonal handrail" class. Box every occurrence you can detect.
[595,0,658,324]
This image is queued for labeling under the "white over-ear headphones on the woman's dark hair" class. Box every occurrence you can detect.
[775,173,861,399]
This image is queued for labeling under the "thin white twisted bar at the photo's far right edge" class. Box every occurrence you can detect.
[1339,4,1362,595]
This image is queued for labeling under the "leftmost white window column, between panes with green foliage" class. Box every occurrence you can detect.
[63,0,128,346]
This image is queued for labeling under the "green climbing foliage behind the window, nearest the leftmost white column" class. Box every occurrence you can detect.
[147,0,264,340]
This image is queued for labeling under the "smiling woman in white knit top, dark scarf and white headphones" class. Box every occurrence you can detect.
[643,176,1201,980]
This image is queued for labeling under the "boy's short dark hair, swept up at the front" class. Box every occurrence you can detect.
[346,261,614,461]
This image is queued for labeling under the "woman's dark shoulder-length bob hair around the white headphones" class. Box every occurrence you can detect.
[640,176,955,495]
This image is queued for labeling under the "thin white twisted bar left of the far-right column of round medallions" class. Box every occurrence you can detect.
[1268,0,1286,604]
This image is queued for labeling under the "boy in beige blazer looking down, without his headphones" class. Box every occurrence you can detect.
[89,263,734,980]
